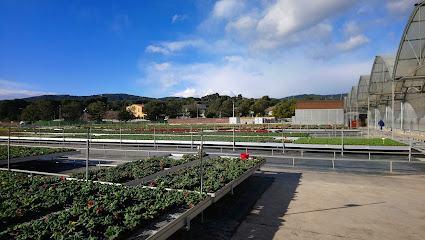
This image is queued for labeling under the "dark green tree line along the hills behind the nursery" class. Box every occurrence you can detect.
[0,93,320,122]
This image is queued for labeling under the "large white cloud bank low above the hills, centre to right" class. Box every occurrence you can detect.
[139,56,373,97]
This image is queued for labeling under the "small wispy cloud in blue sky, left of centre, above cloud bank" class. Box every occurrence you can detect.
[145,40,205,55]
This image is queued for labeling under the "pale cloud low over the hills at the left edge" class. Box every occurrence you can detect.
[0,79,56,100]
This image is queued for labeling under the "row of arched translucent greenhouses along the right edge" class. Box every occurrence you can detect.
[344,1,425,132]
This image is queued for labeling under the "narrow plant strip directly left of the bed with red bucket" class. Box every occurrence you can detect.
[71,153,205,183]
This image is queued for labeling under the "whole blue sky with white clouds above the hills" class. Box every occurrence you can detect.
[0,0,417,100]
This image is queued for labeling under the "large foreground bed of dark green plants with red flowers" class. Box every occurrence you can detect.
[0,172,210,239]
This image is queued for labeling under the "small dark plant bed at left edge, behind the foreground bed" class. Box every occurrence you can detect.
[0,145,75,160]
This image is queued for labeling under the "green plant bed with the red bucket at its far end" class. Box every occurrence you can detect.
[146,157,265,193]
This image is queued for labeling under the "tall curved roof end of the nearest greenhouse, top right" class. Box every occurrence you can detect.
[393,1,425,79]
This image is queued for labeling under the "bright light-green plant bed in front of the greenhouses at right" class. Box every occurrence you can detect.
[294,138,406,146]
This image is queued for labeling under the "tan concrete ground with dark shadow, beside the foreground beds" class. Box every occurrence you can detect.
[231,165,425,240]
